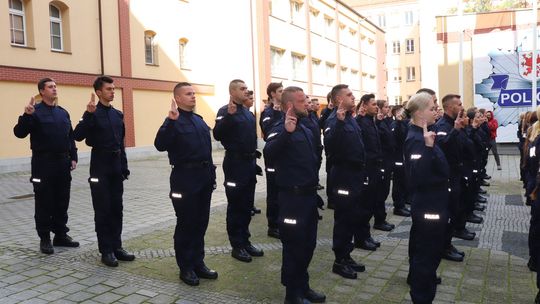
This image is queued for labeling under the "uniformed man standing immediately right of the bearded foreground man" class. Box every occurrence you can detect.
[324,84,370,279]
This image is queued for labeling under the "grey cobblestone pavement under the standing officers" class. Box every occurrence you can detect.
[0,151,536,304]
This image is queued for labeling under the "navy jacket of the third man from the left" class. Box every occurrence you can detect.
[154,109,216,191]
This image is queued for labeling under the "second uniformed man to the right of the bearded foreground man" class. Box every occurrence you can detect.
[357,94,395,236]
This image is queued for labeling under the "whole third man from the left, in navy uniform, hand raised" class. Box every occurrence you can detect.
[154,82,218,286]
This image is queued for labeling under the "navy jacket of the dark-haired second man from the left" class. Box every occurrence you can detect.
[73,102,129,177]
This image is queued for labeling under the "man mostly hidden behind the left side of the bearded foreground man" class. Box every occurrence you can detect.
[259,82,283,239]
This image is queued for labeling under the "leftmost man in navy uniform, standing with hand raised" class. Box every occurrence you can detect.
[13,78,79,254]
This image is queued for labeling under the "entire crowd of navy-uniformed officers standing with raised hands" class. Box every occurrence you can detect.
[14,76,508,303]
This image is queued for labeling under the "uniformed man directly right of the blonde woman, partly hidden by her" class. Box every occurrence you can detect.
[428,89,466,262]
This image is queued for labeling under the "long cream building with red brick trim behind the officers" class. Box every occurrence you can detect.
[0,0,385,171]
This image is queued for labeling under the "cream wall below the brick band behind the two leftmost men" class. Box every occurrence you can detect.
[0,81,122,159]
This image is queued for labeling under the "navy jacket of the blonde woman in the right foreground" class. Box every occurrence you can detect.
[405,124,449,217]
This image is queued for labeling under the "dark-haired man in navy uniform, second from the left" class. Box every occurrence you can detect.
[74,76,135,267]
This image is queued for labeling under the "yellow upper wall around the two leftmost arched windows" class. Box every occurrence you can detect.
[0,0,120,75]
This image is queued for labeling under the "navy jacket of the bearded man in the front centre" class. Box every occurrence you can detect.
[264,118,319,188]
